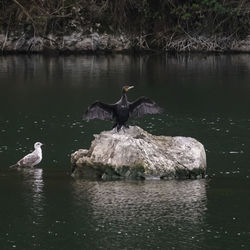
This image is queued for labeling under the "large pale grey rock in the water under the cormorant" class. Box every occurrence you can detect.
[71,126,206,180]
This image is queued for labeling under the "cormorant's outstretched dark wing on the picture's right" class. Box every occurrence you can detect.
[129,96,163,118]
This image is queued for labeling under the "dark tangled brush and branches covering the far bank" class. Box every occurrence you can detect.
[0,0,250,49]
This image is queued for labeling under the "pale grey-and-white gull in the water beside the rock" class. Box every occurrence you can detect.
[10,142,43,168]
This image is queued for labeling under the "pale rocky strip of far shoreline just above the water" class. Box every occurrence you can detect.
[0,32,250,55]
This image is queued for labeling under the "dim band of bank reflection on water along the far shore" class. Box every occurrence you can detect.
[0,54,250,91]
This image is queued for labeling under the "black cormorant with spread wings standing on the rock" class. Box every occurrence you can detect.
[84,86,163,131]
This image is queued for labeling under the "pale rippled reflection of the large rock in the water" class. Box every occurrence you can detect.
[73,180,207,249]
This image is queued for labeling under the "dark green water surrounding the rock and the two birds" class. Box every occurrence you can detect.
[0,55,250,250]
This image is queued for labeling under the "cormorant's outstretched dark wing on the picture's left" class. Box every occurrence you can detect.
[83,101,114,121]
